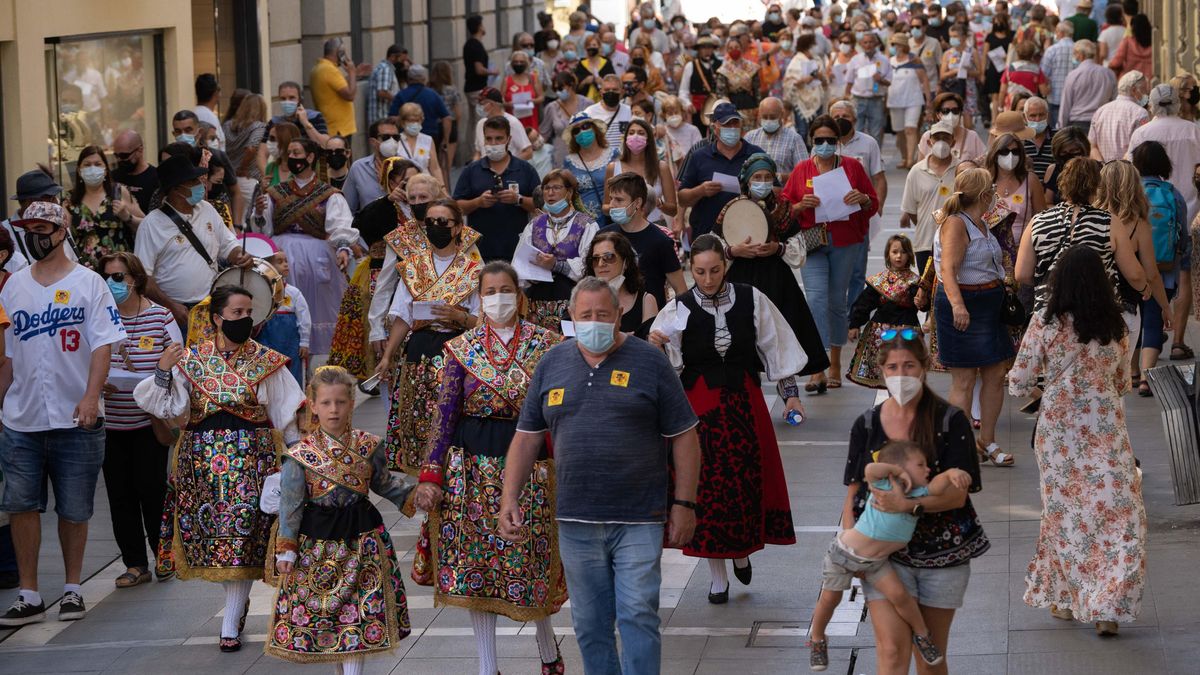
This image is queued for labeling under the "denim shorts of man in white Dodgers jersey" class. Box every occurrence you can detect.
[0,424,104,522]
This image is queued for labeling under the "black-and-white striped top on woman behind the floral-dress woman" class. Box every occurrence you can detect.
[1030,202,1120,311]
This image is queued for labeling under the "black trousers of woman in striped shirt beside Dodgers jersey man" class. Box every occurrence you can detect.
[104,426,167,568]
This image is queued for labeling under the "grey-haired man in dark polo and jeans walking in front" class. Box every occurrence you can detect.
[499,276,700,673]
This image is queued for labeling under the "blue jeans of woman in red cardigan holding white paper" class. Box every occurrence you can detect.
[800,241,866,350]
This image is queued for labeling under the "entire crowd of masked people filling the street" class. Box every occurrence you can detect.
[0,0,1185,675]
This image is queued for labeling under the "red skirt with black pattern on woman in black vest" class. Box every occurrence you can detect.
[683,375,796,558]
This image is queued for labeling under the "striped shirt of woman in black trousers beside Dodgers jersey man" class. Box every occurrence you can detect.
[104,300,184,431]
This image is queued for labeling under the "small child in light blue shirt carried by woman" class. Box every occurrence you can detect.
[809,441,971,670]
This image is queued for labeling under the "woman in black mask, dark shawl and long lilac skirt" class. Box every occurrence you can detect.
[260,138,358,354]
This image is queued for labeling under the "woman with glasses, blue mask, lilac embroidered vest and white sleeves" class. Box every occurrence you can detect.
[521,169,596,333]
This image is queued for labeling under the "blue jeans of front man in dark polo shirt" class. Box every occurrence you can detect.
[558,520,664,675]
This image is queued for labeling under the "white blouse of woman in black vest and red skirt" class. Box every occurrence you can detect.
[650,286,809,381]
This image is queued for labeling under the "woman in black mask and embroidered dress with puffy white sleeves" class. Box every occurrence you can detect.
[133,286,304,651]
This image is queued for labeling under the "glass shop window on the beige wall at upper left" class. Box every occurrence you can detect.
[46,32,166,187]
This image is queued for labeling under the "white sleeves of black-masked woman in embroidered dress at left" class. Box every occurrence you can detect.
[133,355,305,444]
